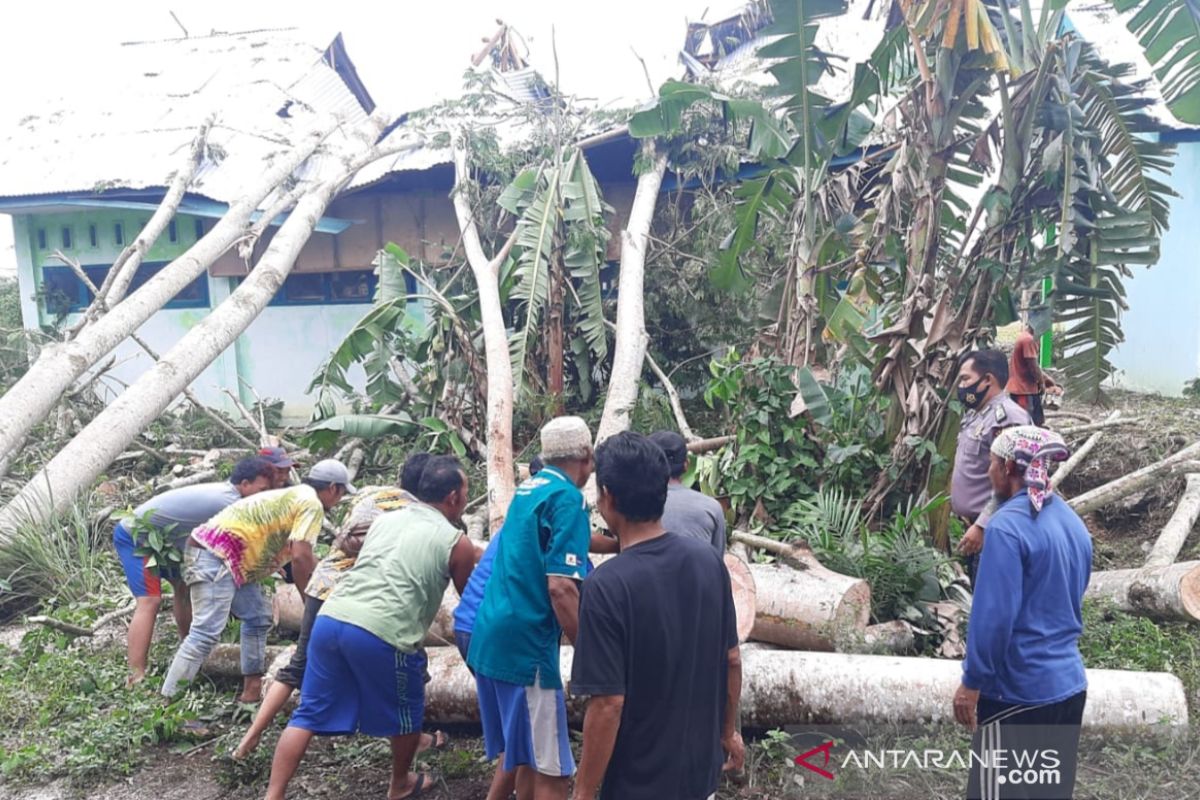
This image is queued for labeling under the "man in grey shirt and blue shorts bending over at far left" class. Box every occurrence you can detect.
[113,457,275,686]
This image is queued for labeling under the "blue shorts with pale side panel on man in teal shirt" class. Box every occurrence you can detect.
[475,673,575,777]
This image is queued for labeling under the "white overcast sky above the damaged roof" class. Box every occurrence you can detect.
[0,0,729,273]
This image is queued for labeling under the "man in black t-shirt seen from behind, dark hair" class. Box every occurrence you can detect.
[570,433,745,800]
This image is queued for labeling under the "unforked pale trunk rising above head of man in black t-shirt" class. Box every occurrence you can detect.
[589,142,667,443]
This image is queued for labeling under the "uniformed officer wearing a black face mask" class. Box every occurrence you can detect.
[950,350,1032,585]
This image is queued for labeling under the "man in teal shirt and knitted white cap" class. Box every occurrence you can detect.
[467,416,592,800]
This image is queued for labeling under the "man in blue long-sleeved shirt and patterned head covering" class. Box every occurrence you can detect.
[954,426,1092,800]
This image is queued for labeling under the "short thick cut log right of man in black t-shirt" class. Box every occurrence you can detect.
[750,558,871,650]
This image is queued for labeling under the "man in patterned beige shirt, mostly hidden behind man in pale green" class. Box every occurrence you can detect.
[233,452,431,758]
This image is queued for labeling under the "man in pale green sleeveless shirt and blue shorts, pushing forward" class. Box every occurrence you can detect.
[266,456,475,800]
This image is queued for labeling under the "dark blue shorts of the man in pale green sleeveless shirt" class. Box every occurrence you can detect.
[288,615,426,736]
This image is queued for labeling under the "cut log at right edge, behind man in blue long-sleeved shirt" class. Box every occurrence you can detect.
[1086,561,1200,623]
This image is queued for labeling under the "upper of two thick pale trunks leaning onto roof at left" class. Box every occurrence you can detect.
[0,112,335,457]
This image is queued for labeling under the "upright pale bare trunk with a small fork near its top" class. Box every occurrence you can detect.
[454,142,516,534]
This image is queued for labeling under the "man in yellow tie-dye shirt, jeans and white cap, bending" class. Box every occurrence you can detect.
[162,458,354,703]
